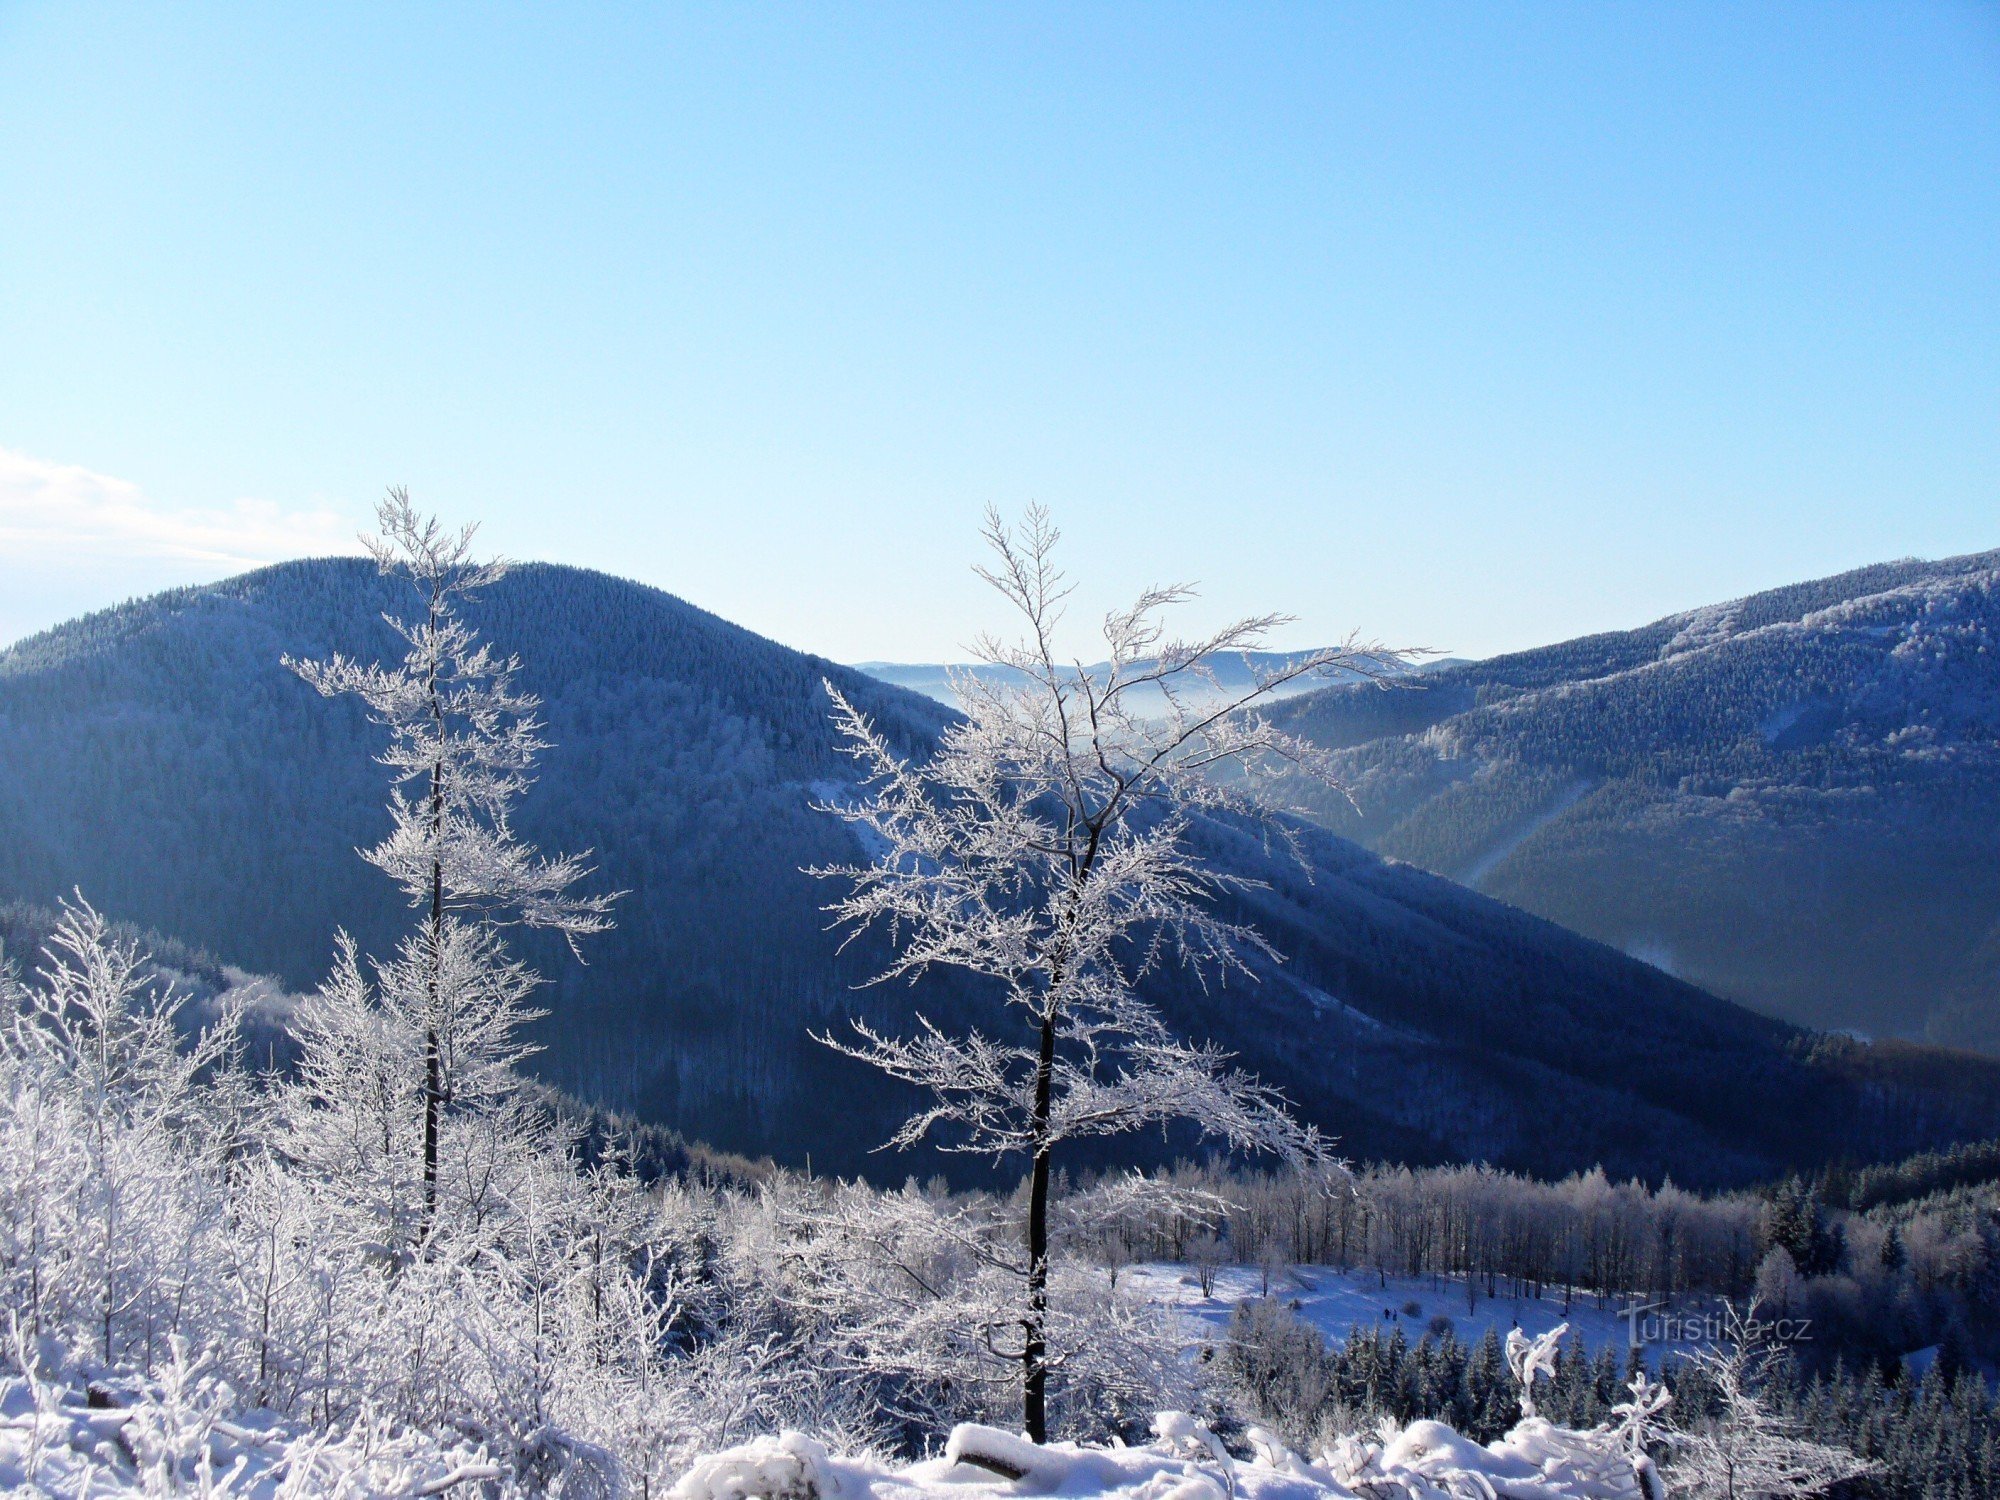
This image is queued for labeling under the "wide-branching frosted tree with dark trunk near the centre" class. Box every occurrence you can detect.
[820,508,1398,1440]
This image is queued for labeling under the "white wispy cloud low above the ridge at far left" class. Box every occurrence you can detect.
[0,448,356,574]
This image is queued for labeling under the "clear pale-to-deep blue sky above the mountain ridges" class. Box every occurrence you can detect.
[0,2,2000,660]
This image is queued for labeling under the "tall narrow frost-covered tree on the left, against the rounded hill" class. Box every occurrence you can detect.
[286,490,614,1226]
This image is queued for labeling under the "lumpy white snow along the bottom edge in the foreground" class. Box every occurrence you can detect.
[0,1380,1662,1500]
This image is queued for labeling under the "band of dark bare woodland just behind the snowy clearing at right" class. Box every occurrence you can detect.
[1092,1146,2000,1368]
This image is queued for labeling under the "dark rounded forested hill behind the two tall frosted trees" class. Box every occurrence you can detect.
[0,560,2000,1182]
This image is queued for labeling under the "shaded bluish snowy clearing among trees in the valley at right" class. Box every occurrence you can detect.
[1118,1262,1708,1368]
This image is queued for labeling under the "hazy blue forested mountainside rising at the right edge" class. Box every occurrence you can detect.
[1276,552,2000,1052]
